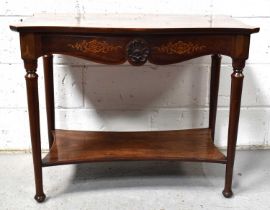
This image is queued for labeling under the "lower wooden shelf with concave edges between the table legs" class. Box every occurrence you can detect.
[43,129,226,166]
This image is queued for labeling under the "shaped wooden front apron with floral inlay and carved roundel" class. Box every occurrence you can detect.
[41,33,237,66]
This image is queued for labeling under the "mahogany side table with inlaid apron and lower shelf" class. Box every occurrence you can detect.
[10,14,259,202]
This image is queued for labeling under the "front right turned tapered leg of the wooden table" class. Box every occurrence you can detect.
[223,61,245,198]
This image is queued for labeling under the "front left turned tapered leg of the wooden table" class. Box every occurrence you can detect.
[24,60,46,202]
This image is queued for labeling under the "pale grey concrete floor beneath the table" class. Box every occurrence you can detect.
[0,150,270,210]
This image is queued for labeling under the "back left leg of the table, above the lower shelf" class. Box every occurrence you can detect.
[43,55,55,148]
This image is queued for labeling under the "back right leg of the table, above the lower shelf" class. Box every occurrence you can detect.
[209,54,221,141]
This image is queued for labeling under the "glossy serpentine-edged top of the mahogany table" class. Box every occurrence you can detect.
[10,14,259,34]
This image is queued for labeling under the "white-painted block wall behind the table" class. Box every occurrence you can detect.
[0,0,270,150]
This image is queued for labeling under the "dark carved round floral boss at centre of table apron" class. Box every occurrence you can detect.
[126,39,150,66]
